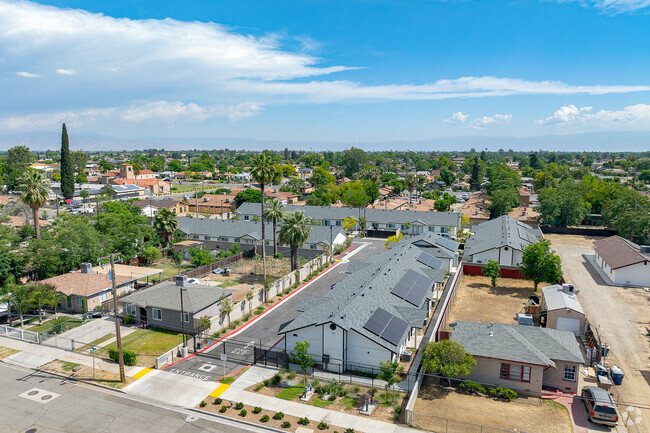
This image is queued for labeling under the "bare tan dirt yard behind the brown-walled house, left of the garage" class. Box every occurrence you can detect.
[450,275,541,323]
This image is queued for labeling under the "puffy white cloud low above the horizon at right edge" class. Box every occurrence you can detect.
[535,104,650,129]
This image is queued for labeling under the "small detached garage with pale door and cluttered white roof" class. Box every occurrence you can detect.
[540,284,585,335]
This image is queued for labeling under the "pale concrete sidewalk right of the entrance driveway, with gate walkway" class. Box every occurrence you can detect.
[221,365,417,433]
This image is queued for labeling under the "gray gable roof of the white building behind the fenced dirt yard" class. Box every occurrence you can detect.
[465,215,542,257]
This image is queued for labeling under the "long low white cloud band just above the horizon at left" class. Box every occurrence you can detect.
[0,101,264,129]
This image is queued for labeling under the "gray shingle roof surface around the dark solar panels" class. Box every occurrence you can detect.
[281,244,430,353]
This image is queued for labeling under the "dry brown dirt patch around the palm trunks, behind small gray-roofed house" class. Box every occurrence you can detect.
[202,257,291,302]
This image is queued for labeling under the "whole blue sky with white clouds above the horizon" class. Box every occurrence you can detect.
[0,0,650,142]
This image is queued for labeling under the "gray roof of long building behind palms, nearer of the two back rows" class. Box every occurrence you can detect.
[178,217,343,245]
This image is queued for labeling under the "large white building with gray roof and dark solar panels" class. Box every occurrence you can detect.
[278,244,439,372]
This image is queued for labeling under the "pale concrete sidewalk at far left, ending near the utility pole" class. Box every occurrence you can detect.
[0,336,119,374]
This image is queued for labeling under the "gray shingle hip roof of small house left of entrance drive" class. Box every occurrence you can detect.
[120,281,234,314]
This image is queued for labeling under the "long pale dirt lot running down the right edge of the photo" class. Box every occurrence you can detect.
[546,235,650,433]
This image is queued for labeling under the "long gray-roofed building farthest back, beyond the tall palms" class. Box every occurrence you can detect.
[236,203,460,237]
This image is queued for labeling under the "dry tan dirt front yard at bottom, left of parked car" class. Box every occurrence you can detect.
[414,385,573,433]
